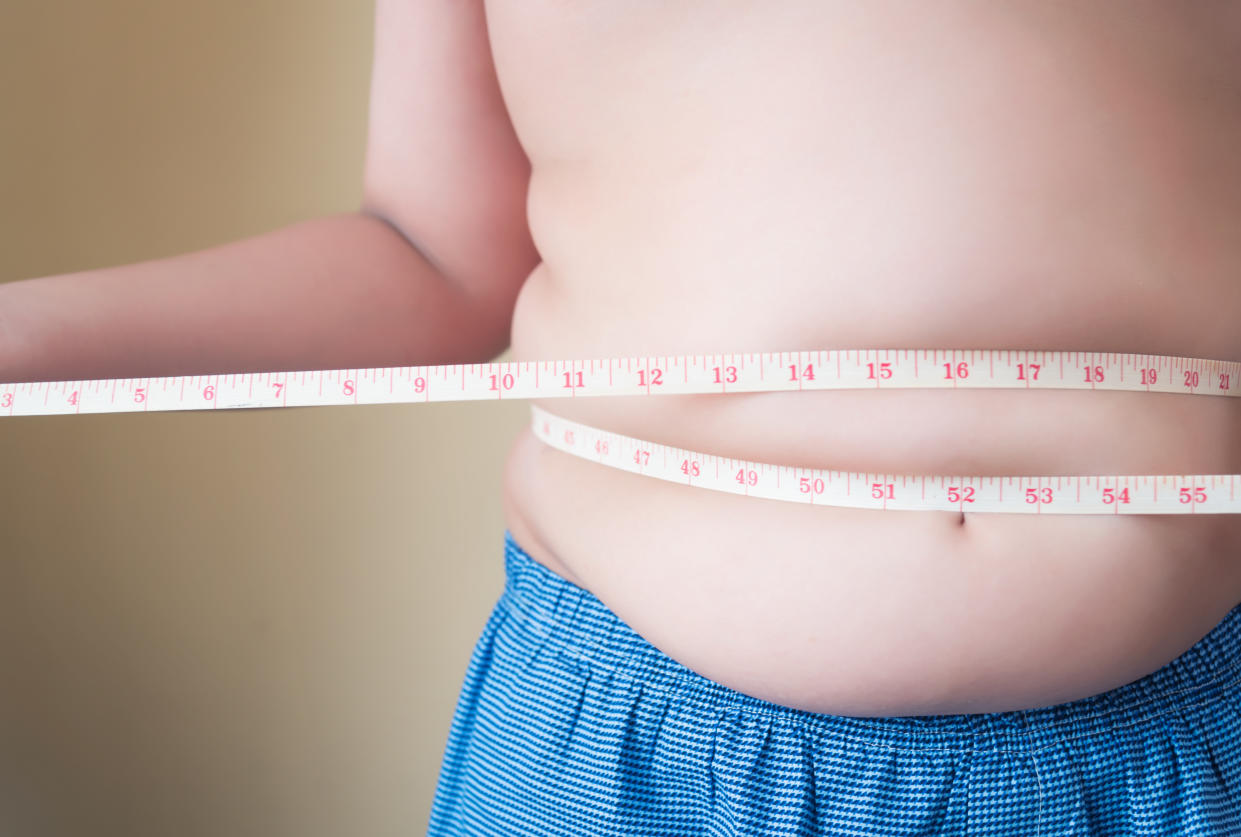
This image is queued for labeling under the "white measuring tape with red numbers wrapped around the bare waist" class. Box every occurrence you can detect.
[0,349,1241,514]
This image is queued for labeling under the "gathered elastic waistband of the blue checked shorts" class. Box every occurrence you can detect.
[500,532,1241,753]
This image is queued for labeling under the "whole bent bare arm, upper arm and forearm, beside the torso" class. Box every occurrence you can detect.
[0,0,537,381]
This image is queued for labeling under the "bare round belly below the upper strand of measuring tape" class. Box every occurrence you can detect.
[505,324,1241,715]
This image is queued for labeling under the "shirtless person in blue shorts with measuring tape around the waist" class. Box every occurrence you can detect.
[7,0,1241,835]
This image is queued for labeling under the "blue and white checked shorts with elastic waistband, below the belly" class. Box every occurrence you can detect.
[429,533,1241,837]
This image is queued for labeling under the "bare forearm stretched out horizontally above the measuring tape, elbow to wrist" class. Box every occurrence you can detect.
[0,214,509,382]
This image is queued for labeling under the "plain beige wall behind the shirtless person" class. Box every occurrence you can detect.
[0,0,526,837]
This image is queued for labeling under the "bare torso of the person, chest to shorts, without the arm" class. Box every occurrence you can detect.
[488,0,1241,715]
